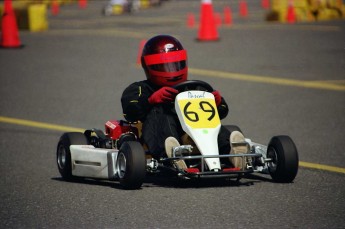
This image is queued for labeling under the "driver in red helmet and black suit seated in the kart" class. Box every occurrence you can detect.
[121,35,248,169]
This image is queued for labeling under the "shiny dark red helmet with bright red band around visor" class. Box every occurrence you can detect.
[141,35,188,86]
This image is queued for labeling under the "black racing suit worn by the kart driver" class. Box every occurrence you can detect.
[121,80,230,158]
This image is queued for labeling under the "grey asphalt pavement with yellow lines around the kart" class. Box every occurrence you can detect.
[0,0,345,228]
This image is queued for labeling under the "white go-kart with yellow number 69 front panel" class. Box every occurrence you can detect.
[56,80,298,189]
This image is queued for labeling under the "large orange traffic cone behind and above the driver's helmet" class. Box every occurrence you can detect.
[197,0,219,41]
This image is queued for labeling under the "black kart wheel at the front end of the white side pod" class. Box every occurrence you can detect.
[116,141,146,189]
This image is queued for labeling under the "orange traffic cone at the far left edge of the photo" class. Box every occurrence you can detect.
[0,0,23,48]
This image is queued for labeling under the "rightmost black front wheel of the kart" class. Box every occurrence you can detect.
[267,136,298,183]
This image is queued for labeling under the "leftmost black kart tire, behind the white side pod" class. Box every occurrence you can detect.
[56,132,88,180]
